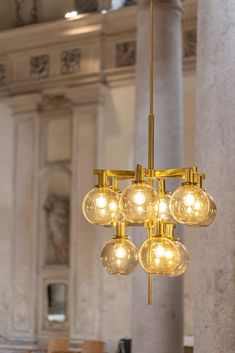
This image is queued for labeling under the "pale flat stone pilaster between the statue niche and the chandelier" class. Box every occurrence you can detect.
[67,84,100,343]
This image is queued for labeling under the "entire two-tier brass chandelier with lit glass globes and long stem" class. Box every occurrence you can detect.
[83,0,216,304]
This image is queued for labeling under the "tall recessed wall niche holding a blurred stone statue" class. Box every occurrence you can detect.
[39,166,71,266]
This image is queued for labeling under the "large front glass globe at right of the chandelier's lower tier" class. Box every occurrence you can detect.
[139,237,180,276]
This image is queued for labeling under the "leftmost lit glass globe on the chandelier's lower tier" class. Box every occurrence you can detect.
[100,238,138,275]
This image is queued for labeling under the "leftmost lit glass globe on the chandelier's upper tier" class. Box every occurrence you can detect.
[82,187,120,225]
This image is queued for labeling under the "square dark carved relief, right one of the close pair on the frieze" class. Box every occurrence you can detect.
[60,49,81,74]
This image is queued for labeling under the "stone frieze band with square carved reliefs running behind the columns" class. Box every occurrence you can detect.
[0,0,196,96]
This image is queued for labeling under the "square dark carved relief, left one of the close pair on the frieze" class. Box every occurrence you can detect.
[30,55,50,79]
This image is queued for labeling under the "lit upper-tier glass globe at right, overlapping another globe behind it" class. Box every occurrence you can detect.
[170,185,210,226]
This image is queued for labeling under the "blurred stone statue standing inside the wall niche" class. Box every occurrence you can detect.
[44,194,69,265]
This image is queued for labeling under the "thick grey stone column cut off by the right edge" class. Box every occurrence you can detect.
[195,0,235,353]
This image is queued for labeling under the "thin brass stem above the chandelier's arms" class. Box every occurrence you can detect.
[148,0,154,169]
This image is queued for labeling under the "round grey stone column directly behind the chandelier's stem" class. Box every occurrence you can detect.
[132,0,183,353]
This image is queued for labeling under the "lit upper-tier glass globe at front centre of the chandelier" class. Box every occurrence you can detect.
[120,183,158,223]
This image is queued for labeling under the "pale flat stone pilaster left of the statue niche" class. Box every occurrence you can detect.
[5,94,40,342]
